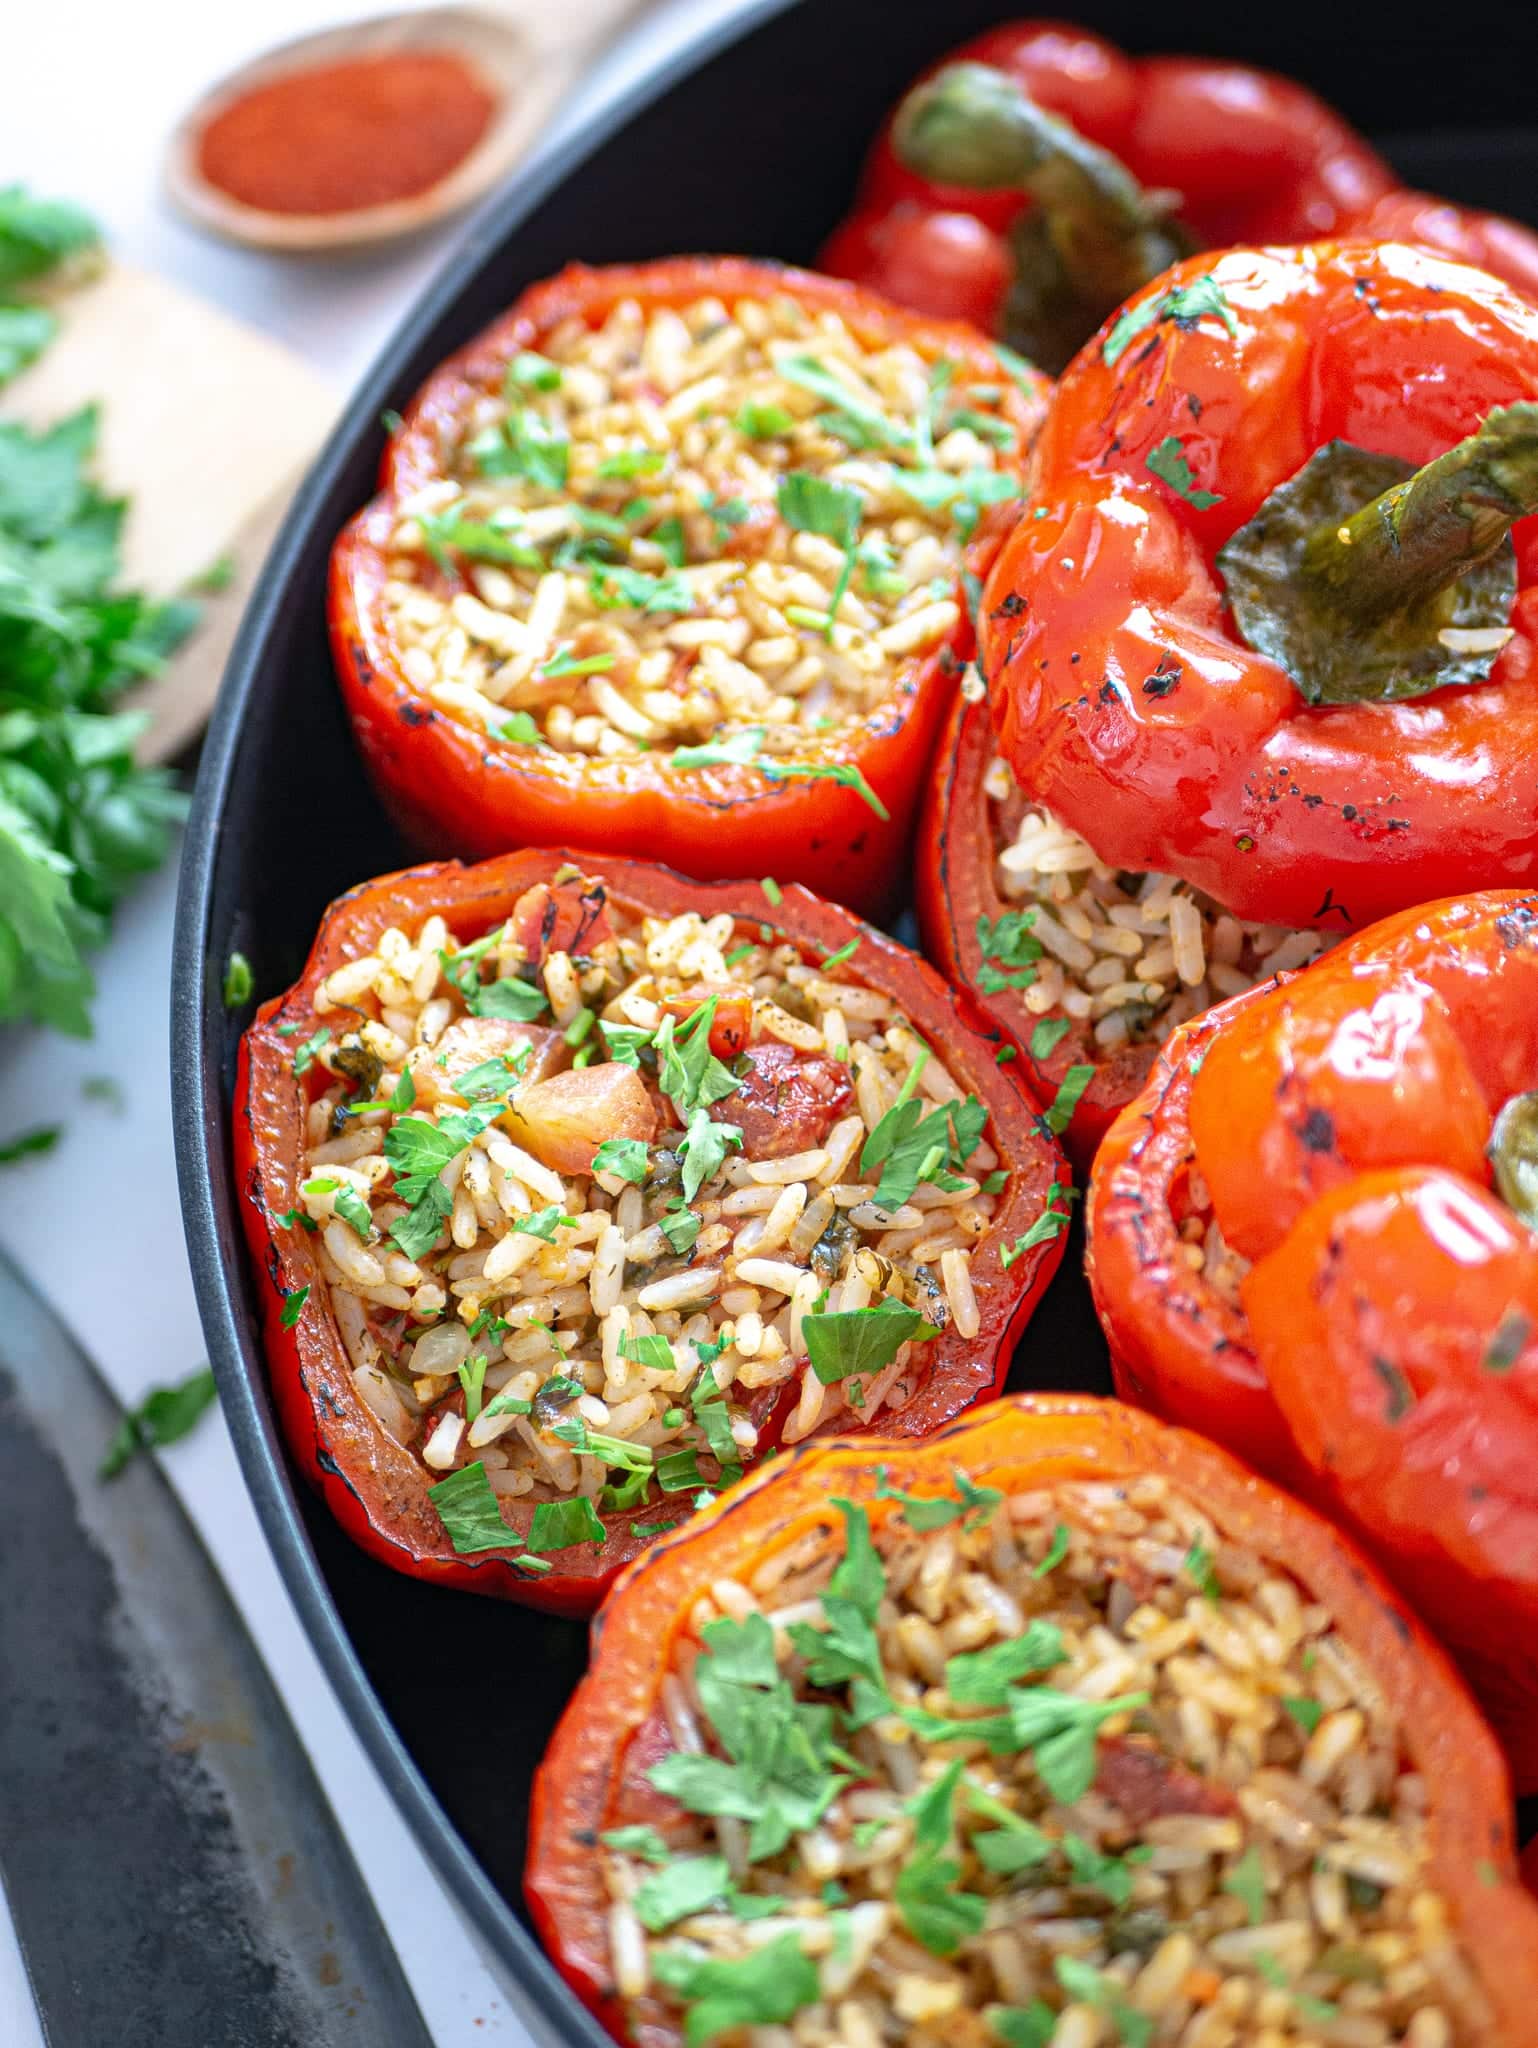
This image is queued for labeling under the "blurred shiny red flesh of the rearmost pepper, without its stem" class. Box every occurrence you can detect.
[821,20,1538,334]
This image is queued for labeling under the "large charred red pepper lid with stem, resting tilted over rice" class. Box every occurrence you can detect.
[981,244,1538,932]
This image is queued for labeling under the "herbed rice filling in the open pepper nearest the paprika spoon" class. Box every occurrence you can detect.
[385,297,1018,766]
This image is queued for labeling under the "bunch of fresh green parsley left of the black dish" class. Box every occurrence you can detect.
[0,186,197,1036]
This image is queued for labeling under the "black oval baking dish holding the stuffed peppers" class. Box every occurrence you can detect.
[172,0,1538,2044]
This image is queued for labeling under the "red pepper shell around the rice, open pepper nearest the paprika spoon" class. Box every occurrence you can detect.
[330,256,1046,911]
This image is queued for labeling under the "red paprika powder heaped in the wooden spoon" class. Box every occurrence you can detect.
[197,49,498,213]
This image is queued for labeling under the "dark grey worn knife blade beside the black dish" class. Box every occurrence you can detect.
[0,1260,430,2048]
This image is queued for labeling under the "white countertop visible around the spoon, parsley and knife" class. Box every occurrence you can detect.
[0,0,782,2048]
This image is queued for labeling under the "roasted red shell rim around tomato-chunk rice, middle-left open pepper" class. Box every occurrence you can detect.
[233,848,1067,1614]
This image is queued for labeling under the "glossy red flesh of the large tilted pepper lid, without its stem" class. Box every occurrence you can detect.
[979,244,1538,930]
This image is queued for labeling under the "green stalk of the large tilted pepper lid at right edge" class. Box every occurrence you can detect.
[1302,401,1538,627]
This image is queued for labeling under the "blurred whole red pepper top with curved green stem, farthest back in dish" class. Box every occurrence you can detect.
[823,20,1538,369]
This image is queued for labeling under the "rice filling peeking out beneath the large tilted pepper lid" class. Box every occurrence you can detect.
[983,760,1329,1055]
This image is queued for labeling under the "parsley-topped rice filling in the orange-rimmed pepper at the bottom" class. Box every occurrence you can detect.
[604,1477,1489,2048]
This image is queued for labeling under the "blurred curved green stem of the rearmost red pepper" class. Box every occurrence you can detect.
[893,63,1190,371]
